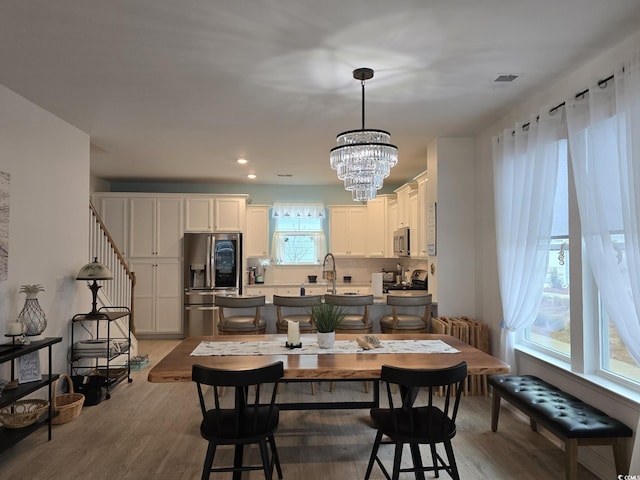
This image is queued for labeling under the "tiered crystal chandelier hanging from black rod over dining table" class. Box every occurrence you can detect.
[329,68,398,202]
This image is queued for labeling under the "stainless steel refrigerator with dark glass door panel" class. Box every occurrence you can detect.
[183,233,243,337]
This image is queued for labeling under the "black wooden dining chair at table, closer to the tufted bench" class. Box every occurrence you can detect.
[364,362,467,480]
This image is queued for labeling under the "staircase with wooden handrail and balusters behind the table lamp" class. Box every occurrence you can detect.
[89,203,138,355]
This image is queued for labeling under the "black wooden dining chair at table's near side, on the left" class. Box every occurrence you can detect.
[191,362,284,480]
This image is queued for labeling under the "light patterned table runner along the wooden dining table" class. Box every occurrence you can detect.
[191,335,460,357]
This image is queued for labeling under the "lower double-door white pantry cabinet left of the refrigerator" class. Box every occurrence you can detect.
[130,258,183,336]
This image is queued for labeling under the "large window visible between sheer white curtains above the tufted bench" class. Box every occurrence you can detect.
[522,136,640,390]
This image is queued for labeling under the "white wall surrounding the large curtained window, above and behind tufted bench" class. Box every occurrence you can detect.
[475,31,640,478]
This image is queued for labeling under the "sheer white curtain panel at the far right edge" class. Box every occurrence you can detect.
[566,53,640,365]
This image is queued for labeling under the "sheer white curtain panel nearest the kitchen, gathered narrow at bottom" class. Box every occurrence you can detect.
[493,108,564,369]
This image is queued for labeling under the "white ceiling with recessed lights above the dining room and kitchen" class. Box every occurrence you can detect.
[0,0,640,185]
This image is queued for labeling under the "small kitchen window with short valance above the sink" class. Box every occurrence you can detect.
[271,203,327,265]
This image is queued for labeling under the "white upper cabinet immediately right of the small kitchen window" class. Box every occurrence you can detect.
[329,206,367,257]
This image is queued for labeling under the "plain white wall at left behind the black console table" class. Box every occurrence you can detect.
[0,85,91,378]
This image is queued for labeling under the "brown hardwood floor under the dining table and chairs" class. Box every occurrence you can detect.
[0,340,597,480]
